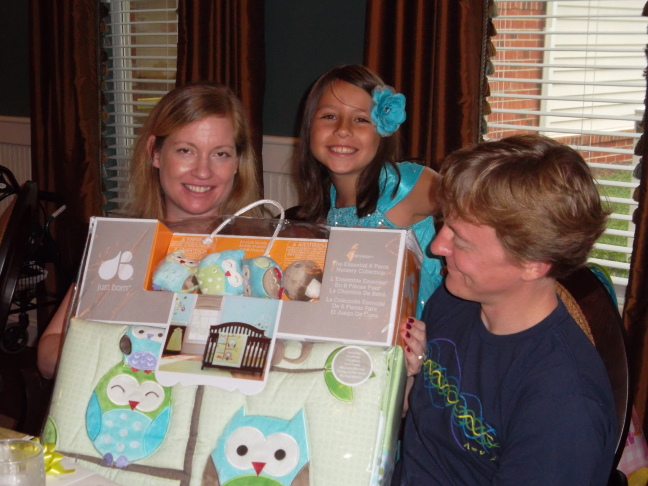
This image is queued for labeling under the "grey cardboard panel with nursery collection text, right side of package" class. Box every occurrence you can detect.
[279,227,422,345]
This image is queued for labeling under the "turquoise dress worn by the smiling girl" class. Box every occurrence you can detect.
[326,162,441,318]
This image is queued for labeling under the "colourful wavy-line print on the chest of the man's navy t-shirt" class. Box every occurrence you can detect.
[423,339,499,459]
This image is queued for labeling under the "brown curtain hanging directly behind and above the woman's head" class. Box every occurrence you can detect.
[176,0,265,190]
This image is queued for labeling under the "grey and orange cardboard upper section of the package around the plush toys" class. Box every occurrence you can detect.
[76,218,422,346]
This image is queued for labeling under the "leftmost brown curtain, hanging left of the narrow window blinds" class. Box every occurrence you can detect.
[29,0,102,288]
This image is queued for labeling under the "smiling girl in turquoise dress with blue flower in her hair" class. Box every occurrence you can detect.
[297,65,441,317]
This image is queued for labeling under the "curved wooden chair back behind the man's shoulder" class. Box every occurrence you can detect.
[558,267,632,486]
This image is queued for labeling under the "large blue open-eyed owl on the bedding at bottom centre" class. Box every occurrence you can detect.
[203,408,310,486]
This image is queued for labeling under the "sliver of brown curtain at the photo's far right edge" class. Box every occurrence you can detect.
[623,3,648,433]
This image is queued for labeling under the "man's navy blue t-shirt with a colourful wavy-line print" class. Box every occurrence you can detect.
[392,286,617,486]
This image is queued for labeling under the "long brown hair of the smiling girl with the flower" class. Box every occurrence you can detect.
[295,64,400,221]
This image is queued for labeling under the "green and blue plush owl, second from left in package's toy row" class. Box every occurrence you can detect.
[196,250,245,295]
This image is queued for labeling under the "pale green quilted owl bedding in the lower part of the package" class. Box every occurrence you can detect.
[43,318,405,486]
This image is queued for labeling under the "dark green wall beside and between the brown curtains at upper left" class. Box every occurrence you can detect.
[0,0,365,131]
